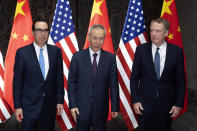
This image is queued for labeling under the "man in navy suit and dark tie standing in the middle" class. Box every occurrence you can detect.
[68,24,119,131]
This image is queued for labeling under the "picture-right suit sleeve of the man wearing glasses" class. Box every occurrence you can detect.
[57,48,64,104]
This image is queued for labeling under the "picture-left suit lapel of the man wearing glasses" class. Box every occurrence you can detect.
[31,43,43,79]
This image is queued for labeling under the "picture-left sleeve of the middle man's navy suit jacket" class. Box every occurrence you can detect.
[68,53,78,109]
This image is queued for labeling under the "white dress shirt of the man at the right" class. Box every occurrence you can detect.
[152,42,167,76]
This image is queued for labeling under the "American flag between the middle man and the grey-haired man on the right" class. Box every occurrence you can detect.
[116,0,148,129]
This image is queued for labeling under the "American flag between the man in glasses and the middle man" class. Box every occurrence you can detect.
[48,0,79,131]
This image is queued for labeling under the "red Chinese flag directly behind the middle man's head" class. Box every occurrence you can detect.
[84,0,114,120]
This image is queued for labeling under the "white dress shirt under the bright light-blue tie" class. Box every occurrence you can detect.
[33,42,49,79]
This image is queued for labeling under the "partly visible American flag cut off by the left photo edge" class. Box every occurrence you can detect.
[0,51,11,123]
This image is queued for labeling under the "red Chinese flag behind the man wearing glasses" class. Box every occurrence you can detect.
[4,0,33,110]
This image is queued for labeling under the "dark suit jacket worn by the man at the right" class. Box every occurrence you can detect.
[130,43,186,111]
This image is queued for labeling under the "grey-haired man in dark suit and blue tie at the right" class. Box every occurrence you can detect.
[130,18,186,131]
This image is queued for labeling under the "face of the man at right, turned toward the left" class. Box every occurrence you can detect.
[150,22,168,46]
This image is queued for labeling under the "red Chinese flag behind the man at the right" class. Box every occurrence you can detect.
[161,0,188,116]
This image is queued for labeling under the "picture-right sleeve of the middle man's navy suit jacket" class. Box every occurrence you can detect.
[110,56,120,112]
